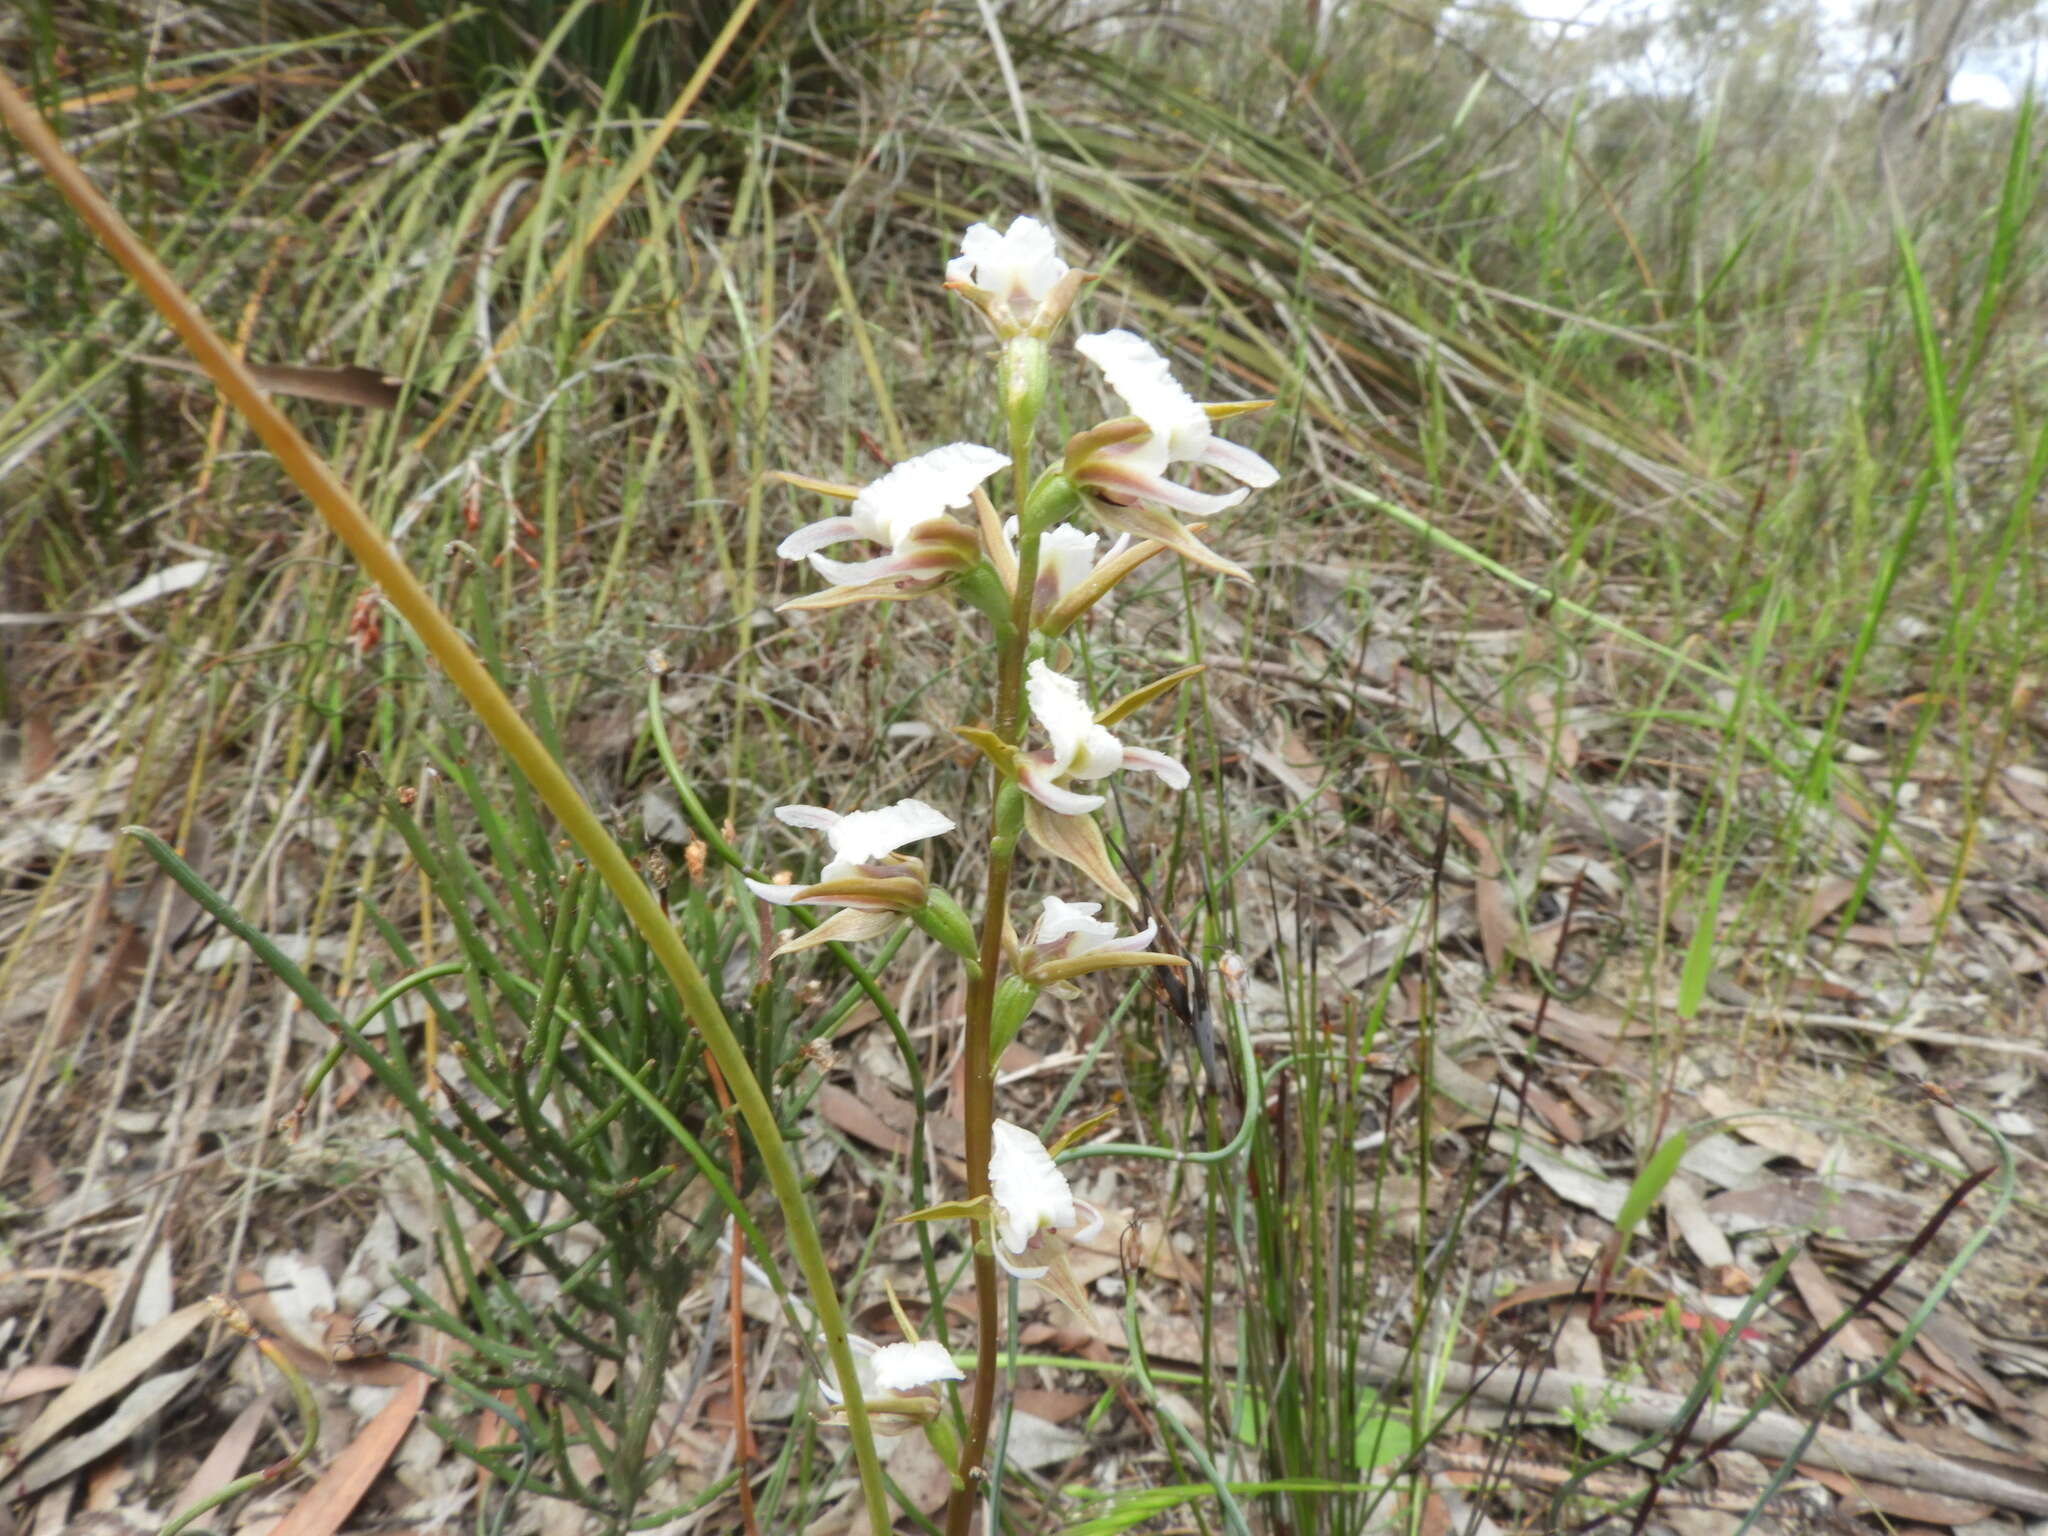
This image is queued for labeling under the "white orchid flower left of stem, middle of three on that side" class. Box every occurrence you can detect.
[748,801,952,956]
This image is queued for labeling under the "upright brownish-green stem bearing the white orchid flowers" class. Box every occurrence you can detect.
[946,342,1042,1536]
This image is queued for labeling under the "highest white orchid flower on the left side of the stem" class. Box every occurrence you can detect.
[776,442,1010,608]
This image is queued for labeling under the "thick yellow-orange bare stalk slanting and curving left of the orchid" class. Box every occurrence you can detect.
[0,74,888,1532]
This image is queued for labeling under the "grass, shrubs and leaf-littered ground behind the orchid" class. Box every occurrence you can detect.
[0,0,2048,1532]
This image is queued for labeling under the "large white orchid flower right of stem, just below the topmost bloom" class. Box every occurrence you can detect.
[1067,330,1280,582]
